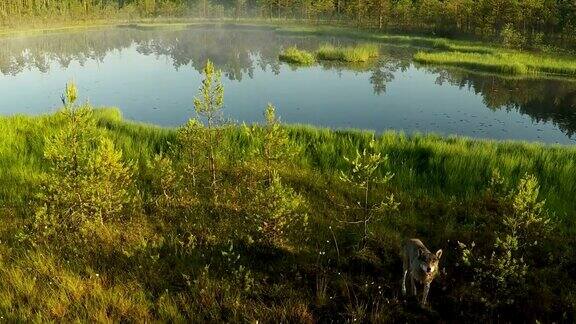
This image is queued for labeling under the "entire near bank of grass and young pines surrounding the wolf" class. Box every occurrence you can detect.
[0,58,576,322]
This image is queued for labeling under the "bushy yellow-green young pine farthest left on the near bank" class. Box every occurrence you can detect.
[34,84,138,251]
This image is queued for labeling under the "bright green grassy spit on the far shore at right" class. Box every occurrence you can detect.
[414,51,576,77]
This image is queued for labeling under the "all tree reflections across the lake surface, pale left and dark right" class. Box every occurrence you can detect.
[0,27,576,136]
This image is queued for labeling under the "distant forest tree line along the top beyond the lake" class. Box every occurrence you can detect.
[0,0,576,38]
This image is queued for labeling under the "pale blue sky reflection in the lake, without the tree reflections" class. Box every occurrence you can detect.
[0,30,576,143]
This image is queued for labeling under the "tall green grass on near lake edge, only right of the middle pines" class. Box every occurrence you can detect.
[290,126,576,219]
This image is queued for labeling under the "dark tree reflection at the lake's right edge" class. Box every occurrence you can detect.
[432,69,576,137]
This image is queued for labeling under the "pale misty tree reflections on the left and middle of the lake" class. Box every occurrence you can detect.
[0,27,409,94]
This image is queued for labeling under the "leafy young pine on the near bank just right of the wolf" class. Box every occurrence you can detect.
[460,172,552,307]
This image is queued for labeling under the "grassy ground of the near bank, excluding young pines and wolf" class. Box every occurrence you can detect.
[0,109,576,322]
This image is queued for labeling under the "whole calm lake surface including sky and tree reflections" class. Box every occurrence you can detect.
[0,27,576,144]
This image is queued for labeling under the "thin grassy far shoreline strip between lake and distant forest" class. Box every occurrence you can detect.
[0,18,576,81]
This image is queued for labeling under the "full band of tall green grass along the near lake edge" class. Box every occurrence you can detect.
[0,109,576,219]
